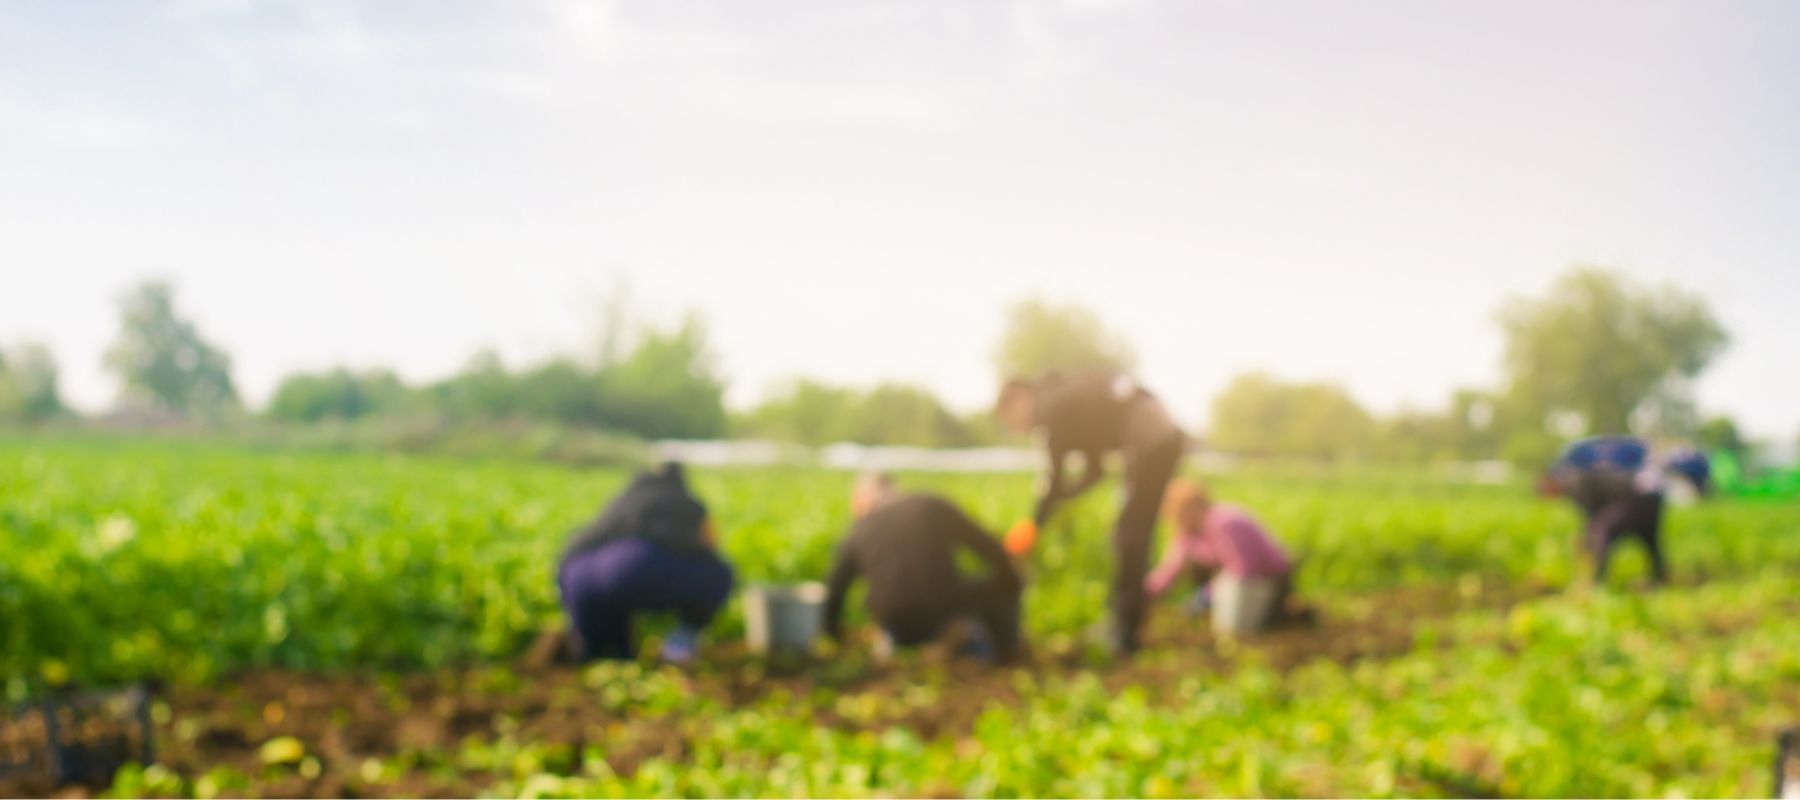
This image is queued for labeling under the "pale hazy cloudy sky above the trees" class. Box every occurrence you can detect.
[0,0,1800,440]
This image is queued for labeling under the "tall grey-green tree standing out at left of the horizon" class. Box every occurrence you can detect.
[106,281,238,418]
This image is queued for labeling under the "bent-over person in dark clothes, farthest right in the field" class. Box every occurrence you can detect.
[1543,436,1669,584]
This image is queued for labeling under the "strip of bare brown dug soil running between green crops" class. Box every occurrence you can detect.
[0,582,1670,796]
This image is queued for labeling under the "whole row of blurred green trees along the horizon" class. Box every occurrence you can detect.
[0,267,1771,463]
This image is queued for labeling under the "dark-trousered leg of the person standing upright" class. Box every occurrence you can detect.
[1111,440,1181,654]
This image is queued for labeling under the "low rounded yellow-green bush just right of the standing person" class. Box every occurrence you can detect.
[1210,373,1375,459]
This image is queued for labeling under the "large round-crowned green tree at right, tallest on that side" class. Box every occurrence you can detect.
[1499,267,1728,436]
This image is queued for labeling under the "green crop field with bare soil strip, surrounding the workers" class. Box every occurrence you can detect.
[0,440,1800,796]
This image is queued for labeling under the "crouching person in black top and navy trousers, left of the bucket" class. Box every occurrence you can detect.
[556,463,733,663]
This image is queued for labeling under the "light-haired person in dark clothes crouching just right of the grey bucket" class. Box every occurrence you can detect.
[824,476,1022,661]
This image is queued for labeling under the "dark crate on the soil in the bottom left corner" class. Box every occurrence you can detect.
[0,685,157,787]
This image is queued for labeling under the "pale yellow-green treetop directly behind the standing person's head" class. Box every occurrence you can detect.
[994,299,1138,380]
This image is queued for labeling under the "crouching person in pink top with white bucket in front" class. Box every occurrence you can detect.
[1143,479,1294,634]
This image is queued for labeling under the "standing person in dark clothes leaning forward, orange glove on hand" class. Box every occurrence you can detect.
[997,371,1188,656]
